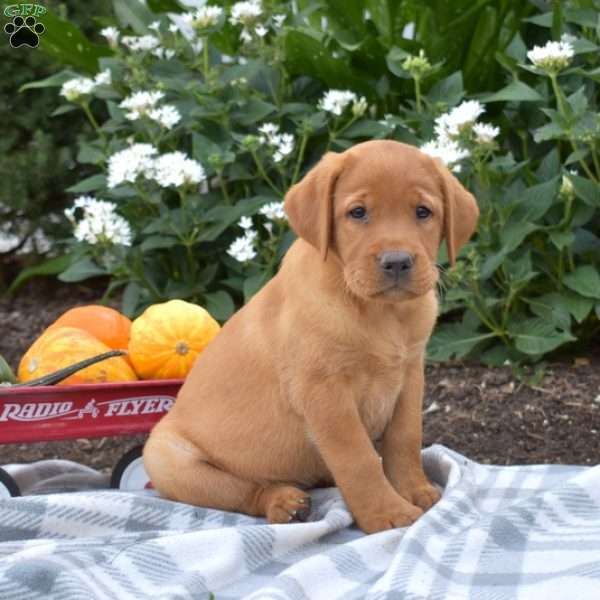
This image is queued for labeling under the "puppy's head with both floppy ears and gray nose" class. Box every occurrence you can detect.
[285,140,479,301]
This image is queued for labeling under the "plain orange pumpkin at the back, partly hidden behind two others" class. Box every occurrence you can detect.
[46,304,131,350]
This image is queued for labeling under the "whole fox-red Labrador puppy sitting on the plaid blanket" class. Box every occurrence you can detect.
[144,141,479,533]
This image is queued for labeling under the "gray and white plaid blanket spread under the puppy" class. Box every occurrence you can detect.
[0,446,600,600]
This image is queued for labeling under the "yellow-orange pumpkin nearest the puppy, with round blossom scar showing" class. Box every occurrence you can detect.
[129,300,221,379]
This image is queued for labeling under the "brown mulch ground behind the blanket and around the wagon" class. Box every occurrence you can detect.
[0,280,600,471]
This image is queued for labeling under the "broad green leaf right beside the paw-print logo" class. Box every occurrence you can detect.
[38,12,113,74]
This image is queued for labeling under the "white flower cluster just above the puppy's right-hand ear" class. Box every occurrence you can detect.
[420,100,500,173]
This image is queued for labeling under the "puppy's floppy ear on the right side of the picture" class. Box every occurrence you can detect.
[434,160,479,265]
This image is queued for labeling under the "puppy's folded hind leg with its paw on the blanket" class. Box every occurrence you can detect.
[144,432,310,523]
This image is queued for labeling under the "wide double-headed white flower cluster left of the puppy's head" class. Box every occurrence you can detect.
[108,144,206,188]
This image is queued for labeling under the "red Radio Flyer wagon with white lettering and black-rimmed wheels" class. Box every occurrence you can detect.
[0,379,183,497]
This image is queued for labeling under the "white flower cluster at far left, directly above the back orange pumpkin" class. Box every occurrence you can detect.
[65,196,133,246]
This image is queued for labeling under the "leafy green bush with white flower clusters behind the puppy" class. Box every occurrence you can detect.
[12,0,600,364]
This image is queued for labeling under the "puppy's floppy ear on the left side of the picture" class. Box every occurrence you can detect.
[284,152,344,260]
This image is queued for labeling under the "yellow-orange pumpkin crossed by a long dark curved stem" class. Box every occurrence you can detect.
[18,327,137,385]
